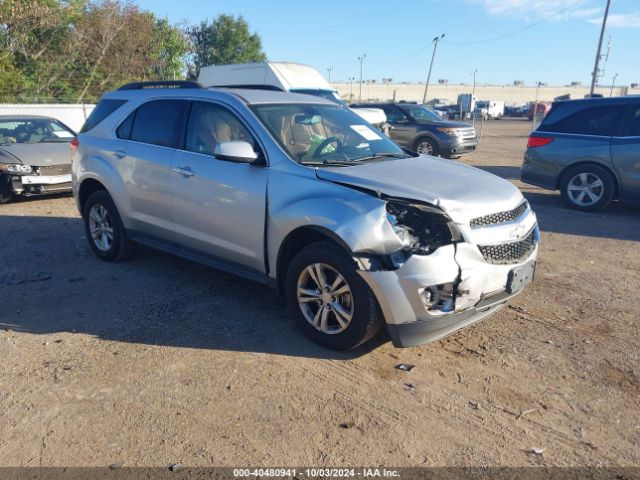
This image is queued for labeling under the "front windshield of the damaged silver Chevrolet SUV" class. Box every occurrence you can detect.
[253,104,408,165]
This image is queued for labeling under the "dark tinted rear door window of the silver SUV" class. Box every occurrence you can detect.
[129,100,188,147]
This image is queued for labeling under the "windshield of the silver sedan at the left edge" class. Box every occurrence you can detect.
[0,118,75,145]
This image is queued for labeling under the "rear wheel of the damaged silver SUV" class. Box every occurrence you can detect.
[82,190,134,262]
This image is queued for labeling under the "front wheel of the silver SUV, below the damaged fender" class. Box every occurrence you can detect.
[285,242,382,350]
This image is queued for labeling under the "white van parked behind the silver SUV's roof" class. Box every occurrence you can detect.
[198,62,387,129]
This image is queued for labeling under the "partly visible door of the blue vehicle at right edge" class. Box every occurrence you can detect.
[611,104,640,199]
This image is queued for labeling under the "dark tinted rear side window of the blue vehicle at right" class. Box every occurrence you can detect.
[538,105,624,137]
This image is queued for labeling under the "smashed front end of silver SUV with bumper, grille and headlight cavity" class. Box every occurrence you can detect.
[359,199,540,347]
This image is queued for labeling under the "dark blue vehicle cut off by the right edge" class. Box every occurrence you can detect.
[521,96,640,211]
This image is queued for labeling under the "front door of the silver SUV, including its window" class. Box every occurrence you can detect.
[171,101,268,273]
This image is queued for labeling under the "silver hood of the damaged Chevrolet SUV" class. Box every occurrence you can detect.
[316,156,523,224]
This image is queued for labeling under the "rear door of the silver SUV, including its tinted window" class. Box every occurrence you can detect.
[112,99,189,242]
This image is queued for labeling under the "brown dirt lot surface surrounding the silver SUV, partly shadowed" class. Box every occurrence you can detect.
[0,120,640,467]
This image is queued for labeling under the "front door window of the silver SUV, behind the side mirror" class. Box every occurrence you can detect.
[185,102,256,155]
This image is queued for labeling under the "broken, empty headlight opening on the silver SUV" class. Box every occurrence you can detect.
[387,201,462,255]
